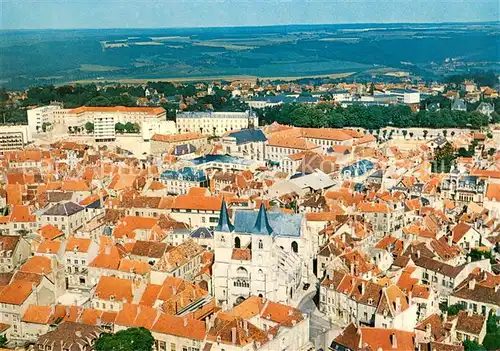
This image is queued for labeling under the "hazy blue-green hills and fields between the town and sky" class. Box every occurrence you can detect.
[0,22,500,88]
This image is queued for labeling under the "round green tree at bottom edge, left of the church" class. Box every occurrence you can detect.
[95,327,154,351]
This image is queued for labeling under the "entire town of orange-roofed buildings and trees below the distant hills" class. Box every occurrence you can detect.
[0,77,500,351]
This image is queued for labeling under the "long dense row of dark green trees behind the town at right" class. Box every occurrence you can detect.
[258,103,500,130]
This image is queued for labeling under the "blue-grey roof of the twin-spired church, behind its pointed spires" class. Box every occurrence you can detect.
[234,210,302,237]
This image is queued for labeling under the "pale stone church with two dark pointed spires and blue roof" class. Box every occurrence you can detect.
[213,201,312,308]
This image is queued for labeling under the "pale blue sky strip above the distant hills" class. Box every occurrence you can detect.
[0,0,500,29]
